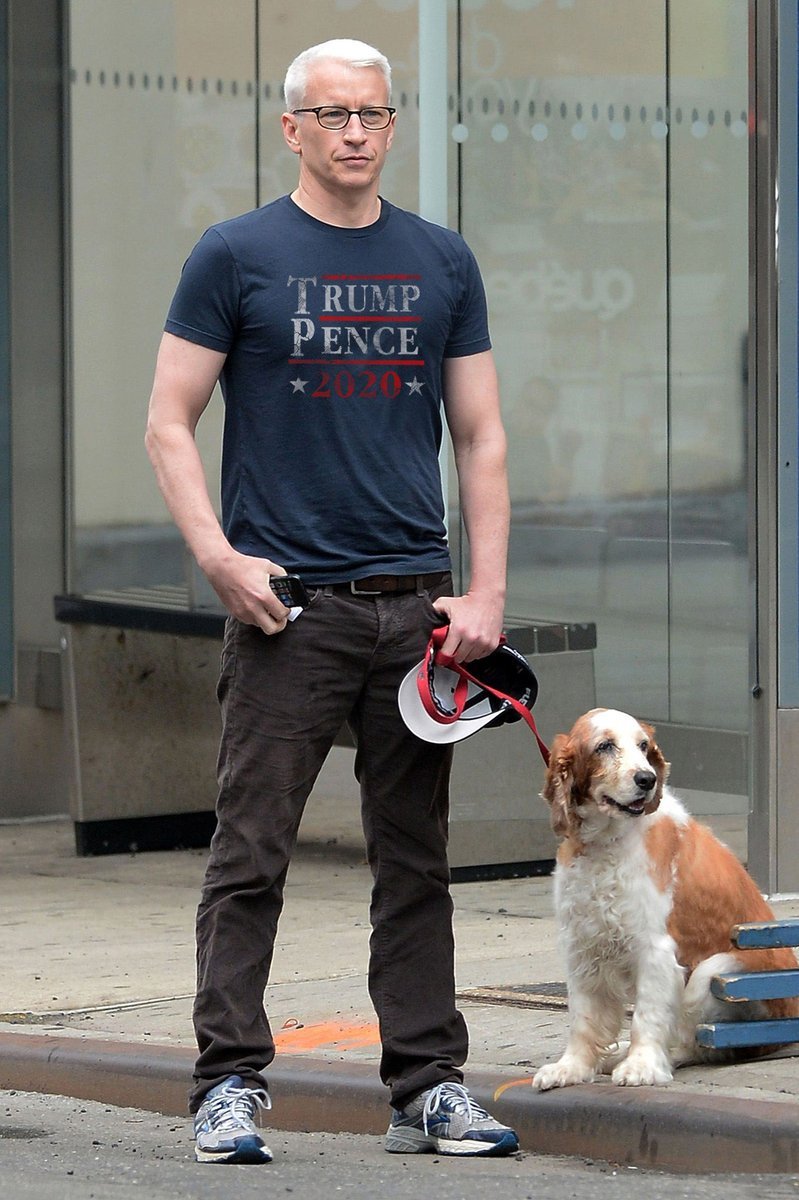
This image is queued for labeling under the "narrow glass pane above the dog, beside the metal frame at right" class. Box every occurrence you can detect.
[668,0,751,730]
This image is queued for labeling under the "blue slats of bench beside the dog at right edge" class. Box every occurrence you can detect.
[696,919,799,1050]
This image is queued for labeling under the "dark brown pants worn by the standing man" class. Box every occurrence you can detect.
[190,575,468,1111]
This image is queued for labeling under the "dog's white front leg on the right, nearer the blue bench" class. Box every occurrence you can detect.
[611,938,683,1087]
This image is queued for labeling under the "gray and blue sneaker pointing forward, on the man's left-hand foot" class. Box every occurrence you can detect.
[194,1075,272,1163]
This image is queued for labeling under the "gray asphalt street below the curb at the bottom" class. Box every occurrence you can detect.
[0,1091,799,1200]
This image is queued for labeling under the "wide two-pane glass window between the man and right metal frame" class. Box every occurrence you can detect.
[453,0,749,731]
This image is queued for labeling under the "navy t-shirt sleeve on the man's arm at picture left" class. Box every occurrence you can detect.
[164,229,241,354]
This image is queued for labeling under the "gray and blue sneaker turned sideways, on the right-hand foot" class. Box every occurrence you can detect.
[385,1082,518,1156]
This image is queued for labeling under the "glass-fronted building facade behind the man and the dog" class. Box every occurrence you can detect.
[0,0,799,892]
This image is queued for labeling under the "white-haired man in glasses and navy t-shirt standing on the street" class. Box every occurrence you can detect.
[146,40,518,1163]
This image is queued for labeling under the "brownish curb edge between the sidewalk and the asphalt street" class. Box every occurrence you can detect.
[0,1032,799,1175]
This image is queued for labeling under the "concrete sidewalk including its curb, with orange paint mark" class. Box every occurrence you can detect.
[0,802,799,1174]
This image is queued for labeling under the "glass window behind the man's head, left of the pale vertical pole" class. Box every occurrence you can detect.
[70,0,419,605]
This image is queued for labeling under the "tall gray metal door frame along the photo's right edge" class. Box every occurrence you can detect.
[749,0,799,894]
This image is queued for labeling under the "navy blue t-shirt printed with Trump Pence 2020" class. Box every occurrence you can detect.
[166,196,491,583]
